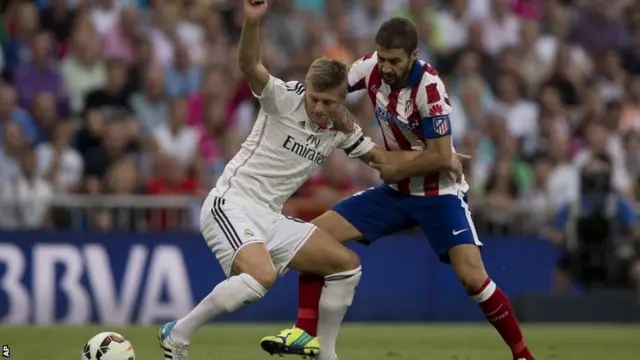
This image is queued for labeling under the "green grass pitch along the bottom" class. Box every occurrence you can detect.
[0,324,640,360]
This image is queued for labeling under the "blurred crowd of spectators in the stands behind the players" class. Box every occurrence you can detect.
[0,0,640,233]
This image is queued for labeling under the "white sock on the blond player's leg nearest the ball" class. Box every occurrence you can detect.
[171,274,267,344]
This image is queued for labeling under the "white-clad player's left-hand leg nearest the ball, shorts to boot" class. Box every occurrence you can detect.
[160,196,277,360]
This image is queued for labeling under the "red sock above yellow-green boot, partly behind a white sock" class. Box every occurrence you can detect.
[296,274,324,336]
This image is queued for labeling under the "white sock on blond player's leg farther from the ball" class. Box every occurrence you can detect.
[318,266,362,360]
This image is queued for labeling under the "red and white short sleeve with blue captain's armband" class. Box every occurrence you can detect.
[416,73,452,139]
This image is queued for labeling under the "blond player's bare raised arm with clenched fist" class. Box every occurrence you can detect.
[239,0,270,94]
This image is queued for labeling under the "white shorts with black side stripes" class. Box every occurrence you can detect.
[200,195,316,277]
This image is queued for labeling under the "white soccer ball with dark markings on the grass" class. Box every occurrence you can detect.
[81,331,136,360]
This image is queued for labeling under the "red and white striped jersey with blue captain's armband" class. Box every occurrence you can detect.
[349,52,469,196]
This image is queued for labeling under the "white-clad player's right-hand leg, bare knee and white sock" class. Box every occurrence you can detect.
[289,224,361,360]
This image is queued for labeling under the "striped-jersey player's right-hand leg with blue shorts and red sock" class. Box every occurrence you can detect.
[407,195,533,360]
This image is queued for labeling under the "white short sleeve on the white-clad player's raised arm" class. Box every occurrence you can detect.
[251,76,305,115]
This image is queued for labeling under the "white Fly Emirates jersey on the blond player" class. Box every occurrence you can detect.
[211,76,375,212]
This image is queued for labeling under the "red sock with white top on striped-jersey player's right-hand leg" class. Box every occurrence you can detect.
[469,278,533,360]
